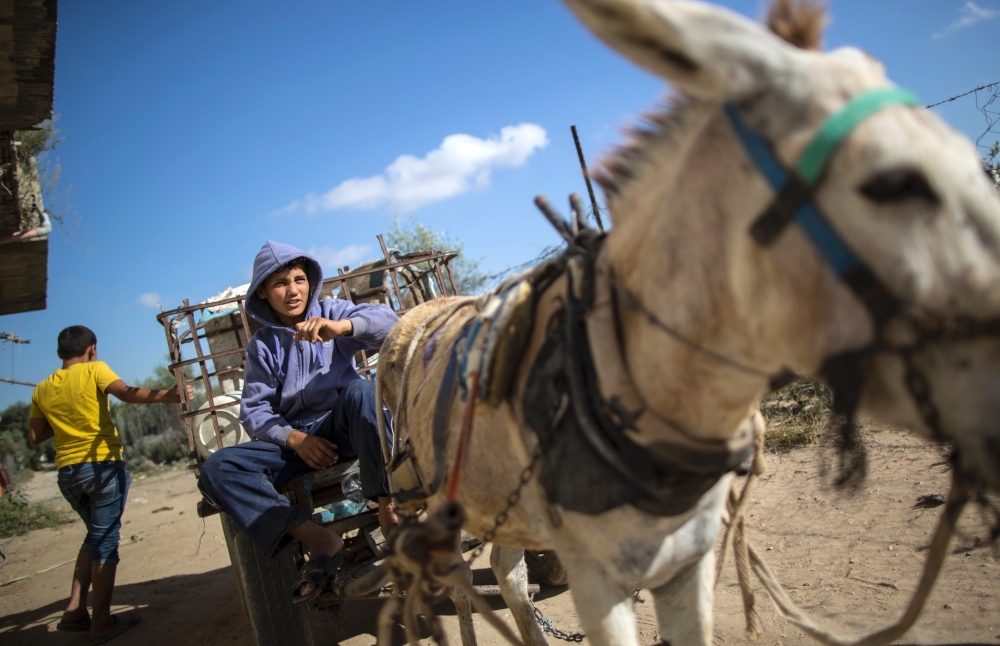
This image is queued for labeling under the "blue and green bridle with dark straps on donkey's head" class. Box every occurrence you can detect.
[725,87,1000,460]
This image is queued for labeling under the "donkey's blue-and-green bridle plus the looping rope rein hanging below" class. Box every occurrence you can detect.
[716,88,988,646]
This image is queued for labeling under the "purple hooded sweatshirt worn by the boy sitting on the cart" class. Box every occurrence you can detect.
[240,240,399,446]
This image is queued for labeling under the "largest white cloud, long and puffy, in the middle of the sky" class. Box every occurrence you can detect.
[280,123,549,214]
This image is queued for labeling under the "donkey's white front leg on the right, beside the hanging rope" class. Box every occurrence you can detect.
[652,551,715,646]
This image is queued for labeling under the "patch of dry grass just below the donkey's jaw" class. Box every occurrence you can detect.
[760,379,833,451]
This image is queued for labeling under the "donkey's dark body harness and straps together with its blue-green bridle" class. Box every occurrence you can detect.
[393,87,1000,516]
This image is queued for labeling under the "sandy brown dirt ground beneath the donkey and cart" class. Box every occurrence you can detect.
[0,431,1000,646]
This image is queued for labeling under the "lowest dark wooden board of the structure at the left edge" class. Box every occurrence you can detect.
[0,239,49,315]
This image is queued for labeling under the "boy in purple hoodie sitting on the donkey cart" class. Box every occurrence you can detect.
[198,240,399,603]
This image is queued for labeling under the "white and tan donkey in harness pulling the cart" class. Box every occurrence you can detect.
[379,0,1000,646]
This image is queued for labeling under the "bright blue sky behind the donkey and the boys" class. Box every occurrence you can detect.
[0,0,1000,407]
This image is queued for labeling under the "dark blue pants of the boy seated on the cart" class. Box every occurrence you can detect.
[198,379,389,555]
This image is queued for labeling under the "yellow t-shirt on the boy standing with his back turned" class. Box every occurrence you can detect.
[31,361,122,469]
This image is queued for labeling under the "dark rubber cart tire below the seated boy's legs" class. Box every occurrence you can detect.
[219,513,313,646]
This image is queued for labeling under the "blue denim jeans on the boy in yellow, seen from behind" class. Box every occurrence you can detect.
[58,460,132,565]
